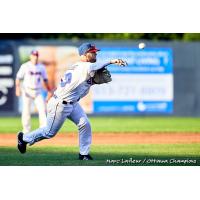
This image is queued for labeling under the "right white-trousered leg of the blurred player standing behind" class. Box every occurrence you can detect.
[34,94,47,128]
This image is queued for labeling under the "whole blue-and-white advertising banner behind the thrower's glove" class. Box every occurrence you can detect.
[92,48,173,113]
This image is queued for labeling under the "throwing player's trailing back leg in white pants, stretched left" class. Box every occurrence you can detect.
[23,98,73,145]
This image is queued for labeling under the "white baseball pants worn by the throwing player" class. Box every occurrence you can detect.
[23,97,92,155]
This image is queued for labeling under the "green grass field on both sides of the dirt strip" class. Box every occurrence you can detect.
[0,117,200,166]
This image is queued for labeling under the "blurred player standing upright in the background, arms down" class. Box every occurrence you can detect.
[15,50,50,133]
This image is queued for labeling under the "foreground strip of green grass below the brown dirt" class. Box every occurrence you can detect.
[0,144,200,166]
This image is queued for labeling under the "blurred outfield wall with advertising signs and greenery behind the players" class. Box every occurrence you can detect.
[0,33,200,116]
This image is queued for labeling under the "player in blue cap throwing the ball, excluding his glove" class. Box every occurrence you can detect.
[17,43,124,160]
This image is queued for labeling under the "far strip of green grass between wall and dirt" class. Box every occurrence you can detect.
[0,117,200,133]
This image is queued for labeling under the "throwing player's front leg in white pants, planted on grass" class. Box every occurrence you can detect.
[68,103,92,158]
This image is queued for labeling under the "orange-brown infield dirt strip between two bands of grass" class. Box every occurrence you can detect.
[0,133,200,147]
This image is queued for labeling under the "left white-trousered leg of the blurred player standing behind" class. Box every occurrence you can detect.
[22,92,32,133]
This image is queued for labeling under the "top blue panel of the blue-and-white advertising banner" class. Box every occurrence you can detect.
[98,48,173,73]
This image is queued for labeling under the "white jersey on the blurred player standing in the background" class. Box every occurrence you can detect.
[16,61,47,90]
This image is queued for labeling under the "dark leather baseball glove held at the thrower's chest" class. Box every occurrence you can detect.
[92,67,112,84]
